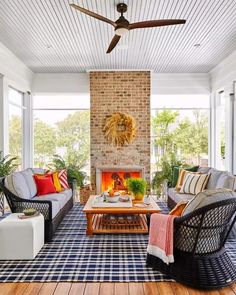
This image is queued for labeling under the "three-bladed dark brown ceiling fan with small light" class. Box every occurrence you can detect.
[70,3,186,53]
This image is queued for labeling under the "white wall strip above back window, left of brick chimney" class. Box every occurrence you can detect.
[32,73,89,93]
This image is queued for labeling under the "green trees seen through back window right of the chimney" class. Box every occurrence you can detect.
[152,110,208,169]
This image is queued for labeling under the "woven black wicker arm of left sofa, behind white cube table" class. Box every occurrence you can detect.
[13,199,52,221]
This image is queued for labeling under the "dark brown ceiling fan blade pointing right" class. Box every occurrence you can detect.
[128,19,186,30]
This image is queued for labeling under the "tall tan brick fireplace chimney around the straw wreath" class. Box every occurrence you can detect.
[90,71,150,193]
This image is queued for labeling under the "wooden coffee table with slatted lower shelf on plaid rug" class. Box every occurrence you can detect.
[83,196,161,235]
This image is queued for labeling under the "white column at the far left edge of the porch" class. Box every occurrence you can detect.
[0,74,9,155]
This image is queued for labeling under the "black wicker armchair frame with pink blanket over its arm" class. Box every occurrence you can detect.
[147,199,236,289]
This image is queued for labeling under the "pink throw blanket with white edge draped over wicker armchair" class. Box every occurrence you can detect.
[147,213,175,264]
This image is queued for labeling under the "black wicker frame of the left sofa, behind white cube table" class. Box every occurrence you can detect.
[0,178,73,242]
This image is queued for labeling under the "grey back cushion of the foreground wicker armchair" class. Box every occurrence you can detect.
[182,188,236,216]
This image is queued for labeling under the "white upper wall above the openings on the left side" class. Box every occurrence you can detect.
[0,43,33,92]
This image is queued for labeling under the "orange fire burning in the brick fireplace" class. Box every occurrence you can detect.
[101,171,141,193]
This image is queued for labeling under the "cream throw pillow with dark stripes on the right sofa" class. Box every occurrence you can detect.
[180,173,211,195]
